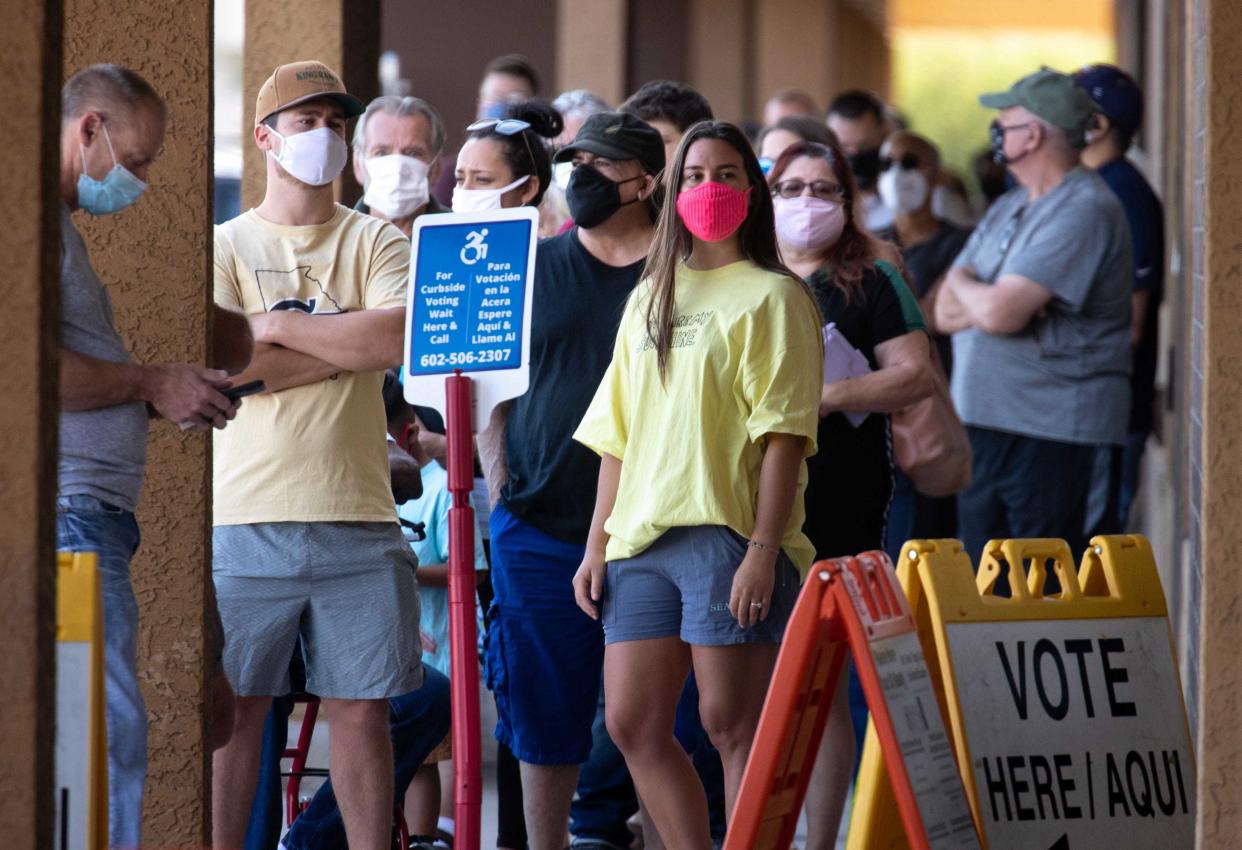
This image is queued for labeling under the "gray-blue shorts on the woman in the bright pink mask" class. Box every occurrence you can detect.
[602,526,800,646]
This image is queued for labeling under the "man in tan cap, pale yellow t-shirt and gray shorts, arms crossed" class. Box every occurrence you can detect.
[212,62,422,850]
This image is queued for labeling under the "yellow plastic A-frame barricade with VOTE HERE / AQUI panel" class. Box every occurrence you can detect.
[847,536,1195,850]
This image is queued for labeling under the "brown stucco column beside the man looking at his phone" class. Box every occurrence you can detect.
[65,0,212,848]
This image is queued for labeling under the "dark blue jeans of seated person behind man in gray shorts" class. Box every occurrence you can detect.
[246,667,452,850]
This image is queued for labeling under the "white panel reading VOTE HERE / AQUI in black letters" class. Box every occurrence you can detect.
[946,618,1195,850]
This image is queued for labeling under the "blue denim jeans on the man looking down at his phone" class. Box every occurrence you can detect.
[56,495,147,850]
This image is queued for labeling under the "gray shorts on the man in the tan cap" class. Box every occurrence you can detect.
[211,522,422,700]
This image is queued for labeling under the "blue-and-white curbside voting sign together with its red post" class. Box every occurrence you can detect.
[404,206,539,850]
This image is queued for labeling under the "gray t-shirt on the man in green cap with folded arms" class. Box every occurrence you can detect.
[953,168,1133,445]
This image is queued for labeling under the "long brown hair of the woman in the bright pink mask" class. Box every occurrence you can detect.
[643,121,815,380]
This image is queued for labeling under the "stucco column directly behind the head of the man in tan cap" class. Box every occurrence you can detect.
[241,0,377,210]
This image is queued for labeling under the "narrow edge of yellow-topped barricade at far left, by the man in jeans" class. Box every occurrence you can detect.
[53,552,108,850]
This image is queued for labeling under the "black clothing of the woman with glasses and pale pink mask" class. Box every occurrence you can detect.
[802,266,922,558]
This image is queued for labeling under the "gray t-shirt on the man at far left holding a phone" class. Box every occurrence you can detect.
[58,206,147,511]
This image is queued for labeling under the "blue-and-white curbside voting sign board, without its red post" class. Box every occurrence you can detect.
[405,206,539,431]
